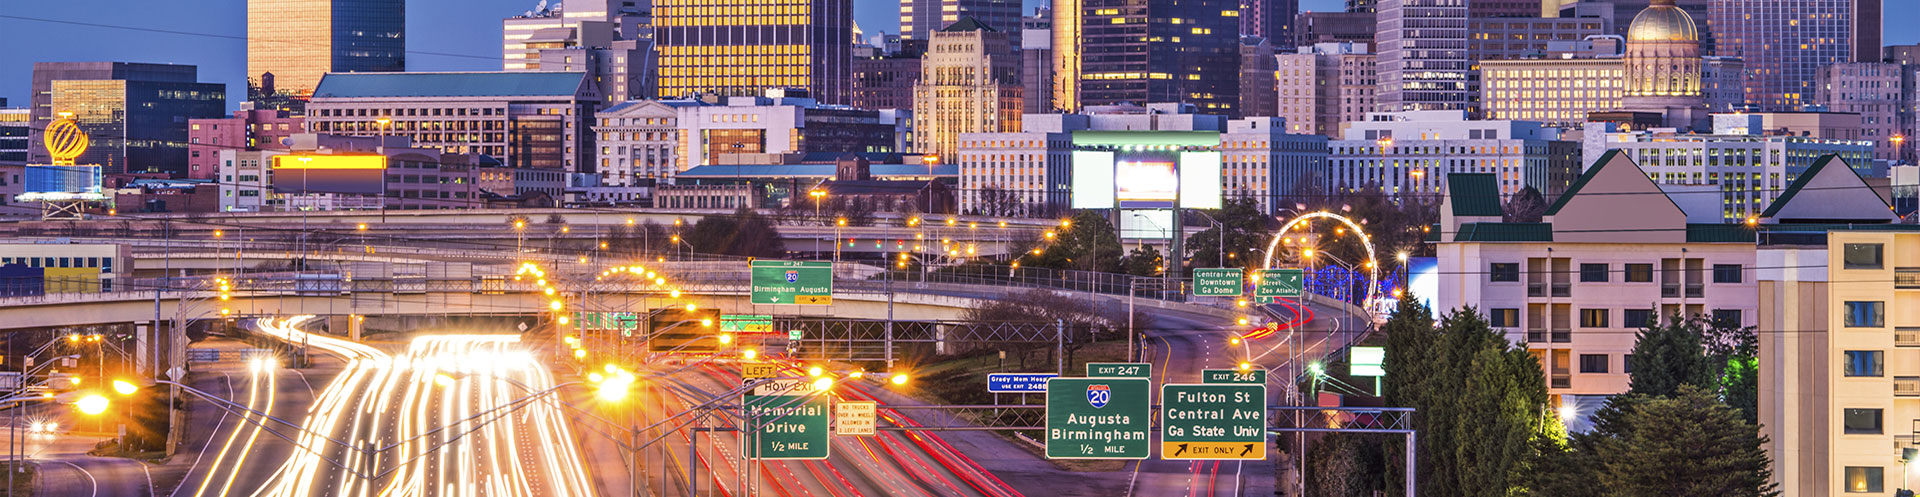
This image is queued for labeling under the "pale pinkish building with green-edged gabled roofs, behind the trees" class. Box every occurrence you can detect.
[1434,152,1757,430]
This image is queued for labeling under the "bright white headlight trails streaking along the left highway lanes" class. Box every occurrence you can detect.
[195,317,595,497]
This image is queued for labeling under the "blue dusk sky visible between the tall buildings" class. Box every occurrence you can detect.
[0,0,1920,107]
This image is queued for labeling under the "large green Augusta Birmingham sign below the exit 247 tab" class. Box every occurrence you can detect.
[1046,378,1154,459]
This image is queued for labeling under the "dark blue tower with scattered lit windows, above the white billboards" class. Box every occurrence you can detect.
[1054,0,1240,117]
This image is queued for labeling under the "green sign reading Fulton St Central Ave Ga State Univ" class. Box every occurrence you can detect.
[1160,384,1267,461]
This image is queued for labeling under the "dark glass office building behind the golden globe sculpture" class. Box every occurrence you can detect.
[27,61,227,177]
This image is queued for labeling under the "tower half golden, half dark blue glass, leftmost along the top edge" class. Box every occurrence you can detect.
[246,0,407,96]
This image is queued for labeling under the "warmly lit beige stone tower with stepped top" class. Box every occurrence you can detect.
[912,17,1025,157]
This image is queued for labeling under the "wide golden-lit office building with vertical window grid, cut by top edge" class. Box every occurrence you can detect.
[653,0,848,104]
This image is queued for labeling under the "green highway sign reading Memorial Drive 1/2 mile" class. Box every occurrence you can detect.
[745,380,833,459]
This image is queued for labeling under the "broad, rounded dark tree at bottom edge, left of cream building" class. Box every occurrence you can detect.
[1601,386,1780,497]
